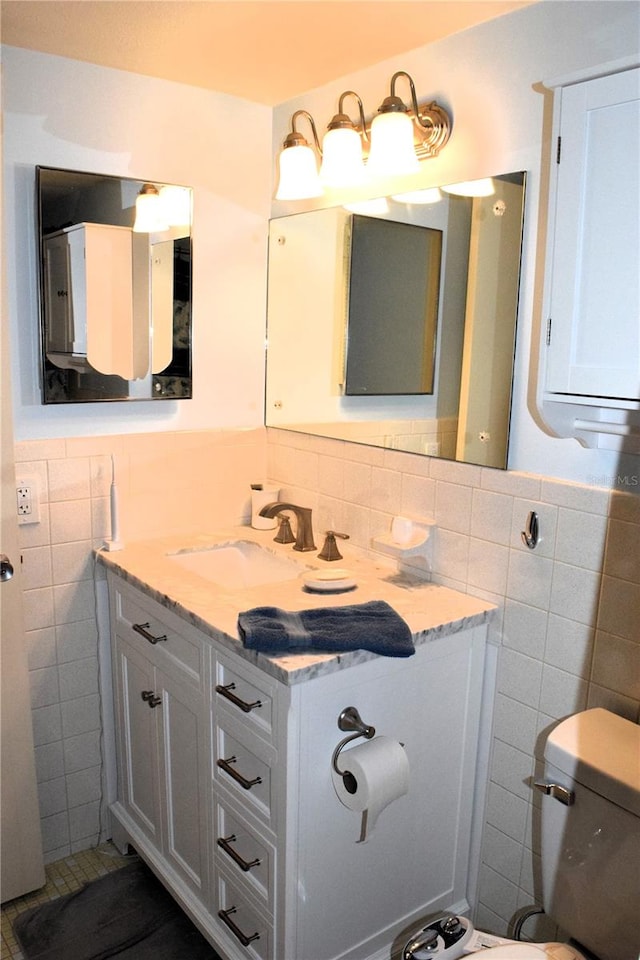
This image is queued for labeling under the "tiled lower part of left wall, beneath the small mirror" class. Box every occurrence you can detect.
[15,430,266,861]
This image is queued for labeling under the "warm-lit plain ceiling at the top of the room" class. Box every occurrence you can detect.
[0,0,532,105]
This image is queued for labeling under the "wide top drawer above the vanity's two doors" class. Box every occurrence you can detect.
[114,586,204,686]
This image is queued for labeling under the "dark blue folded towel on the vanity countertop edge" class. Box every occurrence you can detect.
[238,600,415,657]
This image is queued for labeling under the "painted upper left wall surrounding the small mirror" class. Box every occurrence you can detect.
[2,47,271,441]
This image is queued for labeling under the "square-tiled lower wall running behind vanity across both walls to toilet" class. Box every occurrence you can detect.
[16,429,640,937]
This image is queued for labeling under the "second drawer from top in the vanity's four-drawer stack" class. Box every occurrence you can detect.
[213,722,276,829]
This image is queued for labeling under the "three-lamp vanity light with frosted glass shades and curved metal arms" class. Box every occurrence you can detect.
[276,70,451,200]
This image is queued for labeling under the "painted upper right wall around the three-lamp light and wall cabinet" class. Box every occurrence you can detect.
[272,0,640,485]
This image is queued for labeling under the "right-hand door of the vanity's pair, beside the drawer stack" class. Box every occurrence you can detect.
[156,671,208,900]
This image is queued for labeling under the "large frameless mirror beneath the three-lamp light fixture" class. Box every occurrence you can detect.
[266,172,525,469]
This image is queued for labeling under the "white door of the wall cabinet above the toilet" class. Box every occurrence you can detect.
[546,69,640,400]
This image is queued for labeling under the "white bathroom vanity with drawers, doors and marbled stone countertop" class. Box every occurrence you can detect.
[99,528,492,960]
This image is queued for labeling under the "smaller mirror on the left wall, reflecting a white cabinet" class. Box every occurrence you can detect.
[36,167,192,404]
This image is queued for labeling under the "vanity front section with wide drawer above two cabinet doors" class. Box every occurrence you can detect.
[111,582,208,902]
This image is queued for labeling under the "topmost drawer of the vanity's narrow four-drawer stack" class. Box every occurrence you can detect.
[212,654,274,742]
